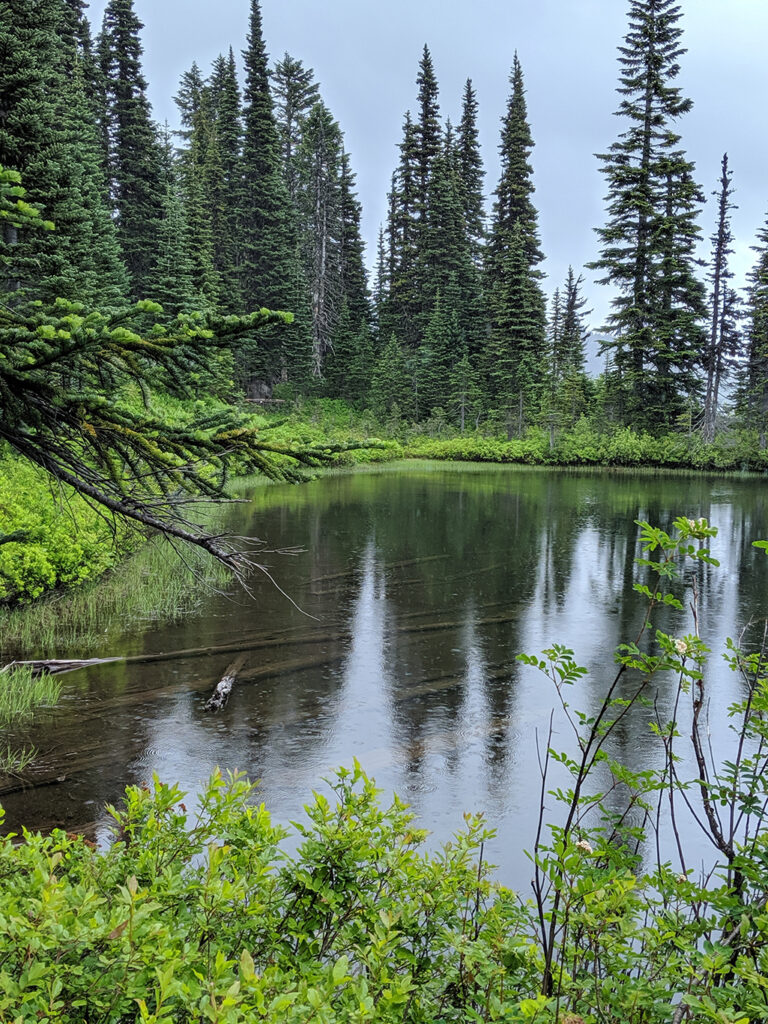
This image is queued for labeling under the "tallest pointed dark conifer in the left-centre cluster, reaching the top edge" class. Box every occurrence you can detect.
[239,0,310,382]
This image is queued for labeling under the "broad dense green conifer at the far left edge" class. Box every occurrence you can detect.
[0,0,124,303]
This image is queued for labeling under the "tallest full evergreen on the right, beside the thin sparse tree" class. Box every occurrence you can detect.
[592,0,705,427]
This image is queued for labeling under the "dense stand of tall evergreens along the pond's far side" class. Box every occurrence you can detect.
[0,0,768,445]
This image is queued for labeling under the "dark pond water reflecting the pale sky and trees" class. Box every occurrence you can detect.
[0,464,768,883]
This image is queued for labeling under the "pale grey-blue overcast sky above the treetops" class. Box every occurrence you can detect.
[90,0,768,326]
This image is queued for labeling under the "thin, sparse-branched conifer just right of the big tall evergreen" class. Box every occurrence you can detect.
[701,153,737,441]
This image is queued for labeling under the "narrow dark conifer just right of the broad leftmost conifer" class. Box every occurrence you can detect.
[100,0,163,298]
